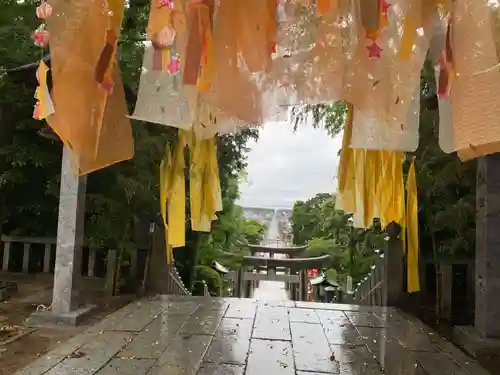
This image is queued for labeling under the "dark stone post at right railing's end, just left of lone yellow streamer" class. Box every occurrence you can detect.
[384,223,404,306]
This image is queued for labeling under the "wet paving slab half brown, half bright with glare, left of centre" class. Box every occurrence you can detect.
[204,318,253,365]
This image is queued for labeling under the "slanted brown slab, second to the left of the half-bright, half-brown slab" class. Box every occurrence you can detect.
[119,314,188,358]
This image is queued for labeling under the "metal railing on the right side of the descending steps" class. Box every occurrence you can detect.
[354,254,387,306]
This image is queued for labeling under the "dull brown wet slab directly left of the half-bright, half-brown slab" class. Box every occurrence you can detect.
[148,334,213,375]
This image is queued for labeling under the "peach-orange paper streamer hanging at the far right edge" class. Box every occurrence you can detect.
[450,0,500,160]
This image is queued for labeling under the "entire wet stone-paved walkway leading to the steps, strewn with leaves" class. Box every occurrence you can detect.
[16,296,489,375]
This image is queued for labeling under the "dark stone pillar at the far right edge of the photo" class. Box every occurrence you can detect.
[475,153,500,338]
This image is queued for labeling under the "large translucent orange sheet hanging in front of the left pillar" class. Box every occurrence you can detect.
[47,0,133,174]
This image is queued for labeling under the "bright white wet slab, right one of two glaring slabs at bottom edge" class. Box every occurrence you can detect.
[290,322,340,374]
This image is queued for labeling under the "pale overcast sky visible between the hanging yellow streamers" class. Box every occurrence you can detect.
[238,122,342,208]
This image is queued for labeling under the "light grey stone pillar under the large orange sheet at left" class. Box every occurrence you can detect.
[52,146,87,314]
